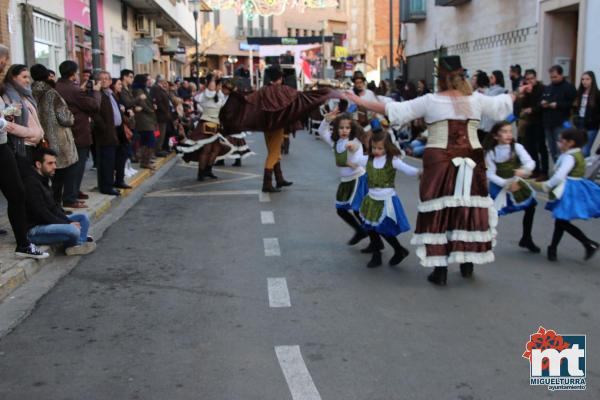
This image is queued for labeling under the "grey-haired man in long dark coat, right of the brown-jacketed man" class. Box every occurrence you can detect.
[93,71,123,196]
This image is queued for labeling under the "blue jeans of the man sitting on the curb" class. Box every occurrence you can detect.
[27,214,90,247]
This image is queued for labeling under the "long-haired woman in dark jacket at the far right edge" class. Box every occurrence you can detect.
[573,71,600,157]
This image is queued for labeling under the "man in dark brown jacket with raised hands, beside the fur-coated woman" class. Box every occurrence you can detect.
[56,60,100,208]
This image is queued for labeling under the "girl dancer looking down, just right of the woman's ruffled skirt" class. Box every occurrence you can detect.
[483,121,540,253]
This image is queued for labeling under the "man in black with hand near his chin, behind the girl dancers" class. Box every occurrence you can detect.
[518,69,548,181]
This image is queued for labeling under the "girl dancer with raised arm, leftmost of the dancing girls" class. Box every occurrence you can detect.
[319,110,368,246]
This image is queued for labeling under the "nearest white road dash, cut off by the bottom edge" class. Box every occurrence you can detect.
[275,346,321,400]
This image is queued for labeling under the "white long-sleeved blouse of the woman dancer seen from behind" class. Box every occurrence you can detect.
[385,92,513,125]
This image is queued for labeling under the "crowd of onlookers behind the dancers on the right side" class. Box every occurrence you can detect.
[378,65,600,170]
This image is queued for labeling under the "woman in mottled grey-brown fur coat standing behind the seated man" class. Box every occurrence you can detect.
[31,64,78,204]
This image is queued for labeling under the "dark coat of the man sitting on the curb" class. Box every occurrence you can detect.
[23,168,71,229]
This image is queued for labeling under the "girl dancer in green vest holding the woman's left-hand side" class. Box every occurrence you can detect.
[360,131,419,268]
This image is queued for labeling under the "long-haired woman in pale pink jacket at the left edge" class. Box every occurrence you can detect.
[3,64,44,162]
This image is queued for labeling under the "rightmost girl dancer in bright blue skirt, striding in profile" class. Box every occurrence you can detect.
[535,129,600,261]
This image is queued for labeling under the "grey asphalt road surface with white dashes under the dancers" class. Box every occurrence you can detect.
[0,134,600,400]
